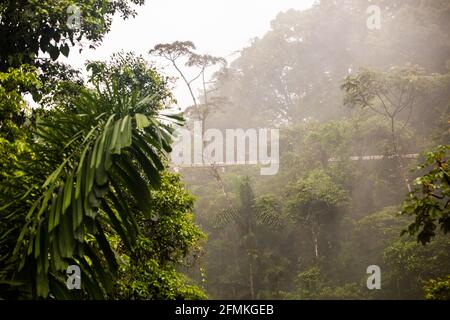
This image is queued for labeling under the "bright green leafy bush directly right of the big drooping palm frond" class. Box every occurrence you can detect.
[113,173,206,300]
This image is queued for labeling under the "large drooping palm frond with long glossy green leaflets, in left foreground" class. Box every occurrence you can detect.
[5,81,182,299]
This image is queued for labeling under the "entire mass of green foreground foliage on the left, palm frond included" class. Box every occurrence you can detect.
[0,1,205,299]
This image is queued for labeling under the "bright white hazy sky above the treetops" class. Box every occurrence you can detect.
[61,0,314,105]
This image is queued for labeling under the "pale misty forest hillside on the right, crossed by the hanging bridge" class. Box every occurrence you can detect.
[178,0,450,299]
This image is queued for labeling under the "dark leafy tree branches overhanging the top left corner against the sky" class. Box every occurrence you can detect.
[0,0,144,71]
